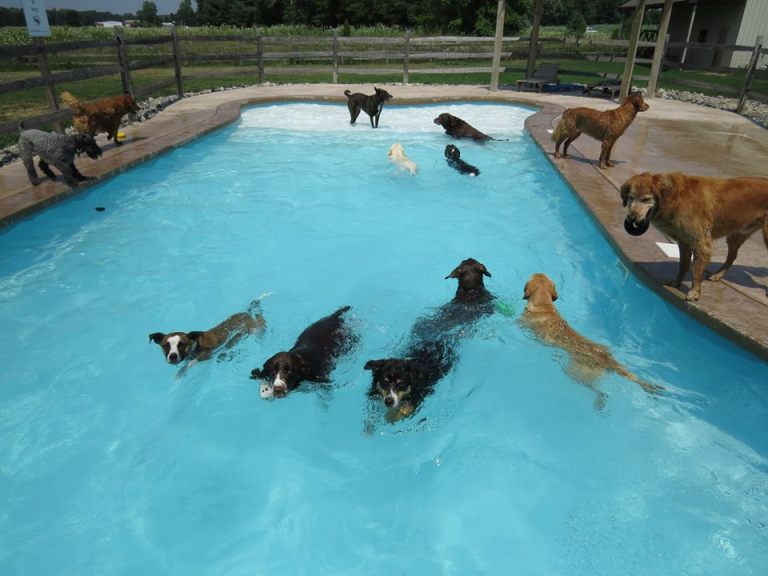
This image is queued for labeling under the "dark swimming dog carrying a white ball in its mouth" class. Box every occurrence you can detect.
[251,306,357,399]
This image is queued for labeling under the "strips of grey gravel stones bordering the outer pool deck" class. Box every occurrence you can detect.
[0,85,768,166]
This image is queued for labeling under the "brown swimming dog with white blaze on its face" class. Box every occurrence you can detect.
[149,296,266,377]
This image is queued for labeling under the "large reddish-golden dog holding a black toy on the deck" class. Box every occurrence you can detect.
[620,172,768,301]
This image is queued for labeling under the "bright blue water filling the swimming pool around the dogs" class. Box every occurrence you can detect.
[0,104,768,576]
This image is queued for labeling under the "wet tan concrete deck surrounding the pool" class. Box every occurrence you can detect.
[0,84,768,360]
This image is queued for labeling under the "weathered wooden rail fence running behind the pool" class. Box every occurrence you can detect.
[0,27,768,134]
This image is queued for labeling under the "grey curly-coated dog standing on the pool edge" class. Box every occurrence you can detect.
[19,129,102,186]
